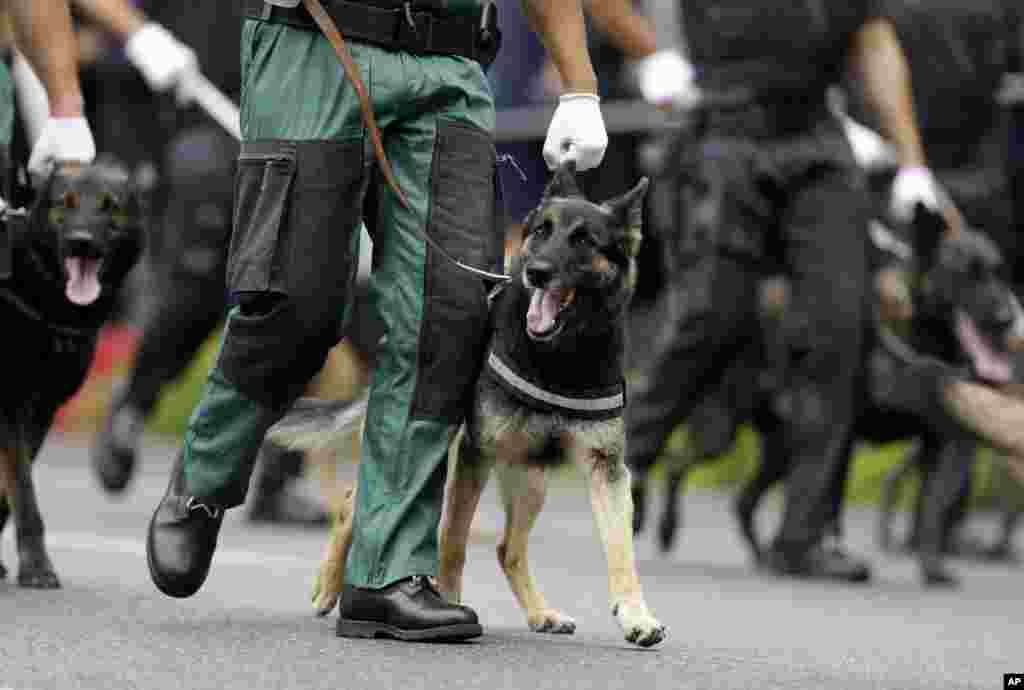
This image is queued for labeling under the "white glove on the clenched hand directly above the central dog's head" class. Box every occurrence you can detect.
[544,93,608,170]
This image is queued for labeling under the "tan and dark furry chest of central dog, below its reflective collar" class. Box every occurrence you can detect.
[469,377,626,465]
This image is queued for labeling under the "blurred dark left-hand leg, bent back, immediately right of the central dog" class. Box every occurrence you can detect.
[626,138,770,510]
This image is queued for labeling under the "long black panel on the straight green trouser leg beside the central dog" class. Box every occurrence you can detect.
[412,122,504,422]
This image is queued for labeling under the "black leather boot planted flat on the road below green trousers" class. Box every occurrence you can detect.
[338,575,483,642]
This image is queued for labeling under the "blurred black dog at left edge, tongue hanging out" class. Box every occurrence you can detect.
[0,161,142,589]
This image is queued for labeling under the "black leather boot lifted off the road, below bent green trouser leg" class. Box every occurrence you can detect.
[145,451,224,598]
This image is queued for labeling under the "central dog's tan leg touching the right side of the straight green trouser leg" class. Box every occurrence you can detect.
[438,428,494,604]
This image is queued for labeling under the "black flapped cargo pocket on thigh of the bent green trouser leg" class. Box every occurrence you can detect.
[227,141,296,293]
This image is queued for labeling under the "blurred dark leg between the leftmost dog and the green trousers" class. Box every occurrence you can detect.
[93,122,238,491]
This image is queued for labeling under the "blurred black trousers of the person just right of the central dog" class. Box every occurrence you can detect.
[627,118,868,554]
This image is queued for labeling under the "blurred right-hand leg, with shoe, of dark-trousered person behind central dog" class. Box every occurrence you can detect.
[769,166,869,580]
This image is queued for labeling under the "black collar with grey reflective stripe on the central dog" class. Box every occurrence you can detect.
[485,350,626,419]
